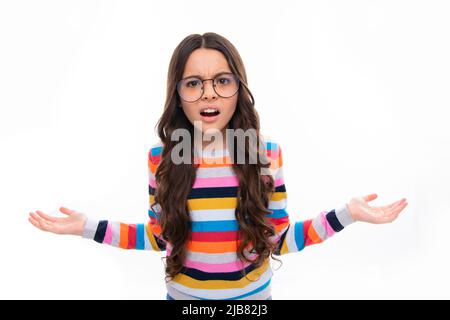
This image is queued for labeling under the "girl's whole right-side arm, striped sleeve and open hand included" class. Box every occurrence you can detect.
[267,143,408,255]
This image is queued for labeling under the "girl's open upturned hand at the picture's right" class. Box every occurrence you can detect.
[347,193,408,224]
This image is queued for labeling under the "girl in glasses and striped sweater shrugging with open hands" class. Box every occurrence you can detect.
[29,33,407,299]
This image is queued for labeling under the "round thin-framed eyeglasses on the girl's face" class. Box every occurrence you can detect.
[177,73,239,102]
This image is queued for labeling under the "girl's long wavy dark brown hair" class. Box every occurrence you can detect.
[152,32,275,278]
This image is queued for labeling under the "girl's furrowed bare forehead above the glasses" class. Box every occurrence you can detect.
[183,48,231,78]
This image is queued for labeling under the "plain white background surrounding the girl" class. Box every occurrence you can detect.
[0,0,450,299]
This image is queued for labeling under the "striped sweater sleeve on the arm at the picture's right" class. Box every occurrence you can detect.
[267,142,354,255]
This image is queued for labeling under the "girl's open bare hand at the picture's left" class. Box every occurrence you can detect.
[28,207,87,236]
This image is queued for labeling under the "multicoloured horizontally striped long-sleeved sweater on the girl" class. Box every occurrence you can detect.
[83,139,353,300]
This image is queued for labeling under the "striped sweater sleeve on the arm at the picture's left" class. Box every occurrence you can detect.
[82,147,166,251]
